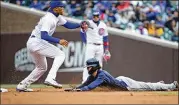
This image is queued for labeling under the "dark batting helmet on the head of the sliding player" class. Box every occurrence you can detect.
[86,58,101,75]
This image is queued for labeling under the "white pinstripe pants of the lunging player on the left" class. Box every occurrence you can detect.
[21,38,65,85]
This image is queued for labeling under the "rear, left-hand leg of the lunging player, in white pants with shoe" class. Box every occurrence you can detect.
[17,52,47,91]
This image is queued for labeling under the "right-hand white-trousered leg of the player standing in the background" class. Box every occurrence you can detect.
[95,45,104,67]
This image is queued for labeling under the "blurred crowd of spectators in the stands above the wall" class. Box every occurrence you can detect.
[3,0,179,42]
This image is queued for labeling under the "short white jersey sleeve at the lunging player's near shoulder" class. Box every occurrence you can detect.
[40,18,53,33]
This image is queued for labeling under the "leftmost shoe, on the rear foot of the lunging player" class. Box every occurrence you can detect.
[16,83,33,92]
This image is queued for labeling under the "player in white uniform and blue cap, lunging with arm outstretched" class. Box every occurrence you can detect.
[16,1,80,92]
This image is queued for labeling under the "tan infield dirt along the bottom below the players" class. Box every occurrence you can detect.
[1,88,178,104]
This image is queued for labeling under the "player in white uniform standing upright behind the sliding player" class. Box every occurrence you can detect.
[80,11,111,83]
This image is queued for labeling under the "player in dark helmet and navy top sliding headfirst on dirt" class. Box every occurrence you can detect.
[65,58,178,91]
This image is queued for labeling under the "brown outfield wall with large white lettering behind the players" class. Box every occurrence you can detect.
[0,4,178,84]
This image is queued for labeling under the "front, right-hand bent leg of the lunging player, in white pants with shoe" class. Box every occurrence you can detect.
[27,38,65,88]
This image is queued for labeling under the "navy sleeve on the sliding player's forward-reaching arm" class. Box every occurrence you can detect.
[80,75,104,91]
